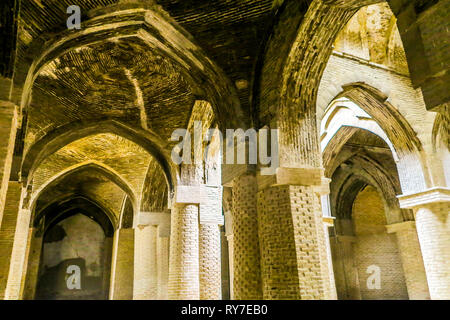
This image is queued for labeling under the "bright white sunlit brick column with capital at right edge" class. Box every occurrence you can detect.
[399,188,450,300]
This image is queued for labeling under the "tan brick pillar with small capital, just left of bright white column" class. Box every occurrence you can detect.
[386,221,430,300]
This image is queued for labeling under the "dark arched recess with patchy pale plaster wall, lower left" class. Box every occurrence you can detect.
[35,207,113,300]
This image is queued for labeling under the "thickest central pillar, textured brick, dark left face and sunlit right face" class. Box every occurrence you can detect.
[258,168,331,300]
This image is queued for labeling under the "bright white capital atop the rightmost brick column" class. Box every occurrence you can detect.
[397,187,450,209]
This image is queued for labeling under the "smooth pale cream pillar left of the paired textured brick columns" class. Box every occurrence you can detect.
[133,225,158,300]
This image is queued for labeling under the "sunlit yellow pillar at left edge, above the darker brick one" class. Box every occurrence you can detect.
[0,101,18,225]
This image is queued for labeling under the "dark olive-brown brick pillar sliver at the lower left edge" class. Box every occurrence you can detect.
[0,181,22,300]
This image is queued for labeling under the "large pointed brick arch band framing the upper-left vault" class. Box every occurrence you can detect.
[20,4,245,128]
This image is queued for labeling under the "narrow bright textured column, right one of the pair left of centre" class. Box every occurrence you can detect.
[199,223,222,300]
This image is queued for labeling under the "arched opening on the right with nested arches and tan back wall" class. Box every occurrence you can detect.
[325,127,423,300]
